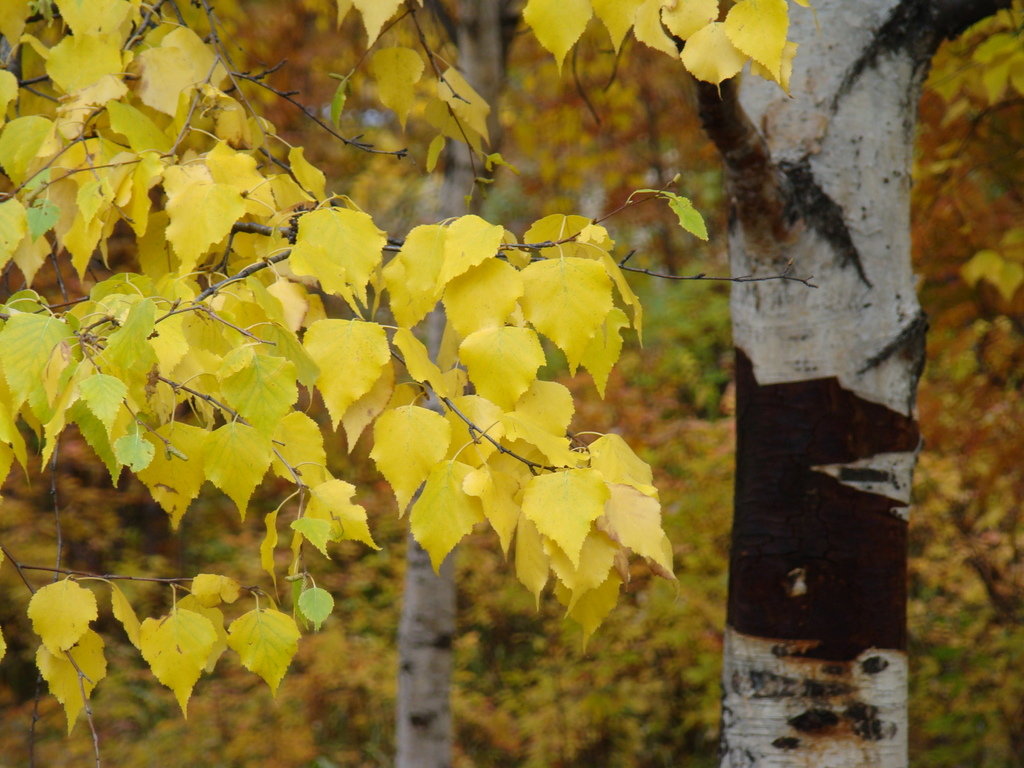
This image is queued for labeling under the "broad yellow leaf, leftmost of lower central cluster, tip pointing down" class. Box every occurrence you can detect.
[370,406,452,514]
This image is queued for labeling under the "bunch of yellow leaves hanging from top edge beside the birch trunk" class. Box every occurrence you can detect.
[523,0,808,90]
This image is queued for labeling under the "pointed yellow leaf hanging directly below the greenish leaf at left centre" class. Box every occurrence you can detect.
[203,421,272,519]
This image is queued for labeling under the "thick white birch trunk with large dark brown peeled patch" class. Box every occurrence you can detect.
[698,0,1007,768]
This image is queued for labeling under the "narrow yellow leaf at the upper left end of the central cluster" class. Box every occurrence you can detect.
[384,224,446,328]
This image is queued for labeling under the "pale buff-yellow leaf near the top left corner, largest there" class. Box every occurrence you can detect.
[135,27,226,117]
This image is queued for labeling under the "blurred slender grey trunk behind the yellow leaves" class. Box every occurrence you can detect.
[395,0,516,768]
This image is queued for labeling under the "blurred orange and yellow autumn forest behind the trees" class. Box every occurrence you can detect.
[0,0,1024,768]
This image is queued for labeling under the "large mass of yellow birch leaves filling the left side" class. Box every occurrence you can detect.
[0,0,699,725]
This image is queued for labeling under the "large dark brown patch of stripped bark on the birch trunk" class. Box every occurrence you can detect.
[728,350,920,662]
